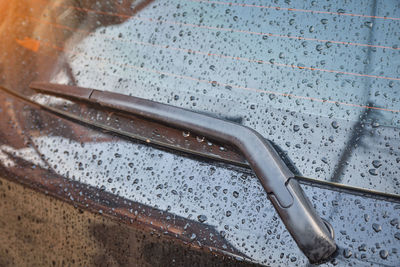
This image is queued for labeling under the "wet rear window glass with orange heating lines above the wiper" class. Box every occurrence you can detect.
[0,0,400,194]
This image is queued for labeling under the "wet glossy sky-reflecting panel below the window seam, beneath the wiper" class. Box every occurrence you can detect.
[0,91,400,266]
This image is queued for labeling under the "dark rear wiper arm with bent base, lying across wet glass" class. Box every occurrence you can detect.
[30,82,336,263]
